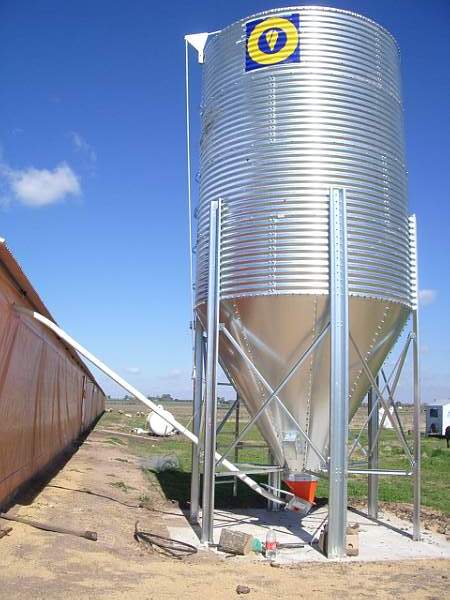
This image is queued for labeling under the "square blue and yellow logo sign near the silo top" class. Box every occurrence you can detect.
[245,13,300,71]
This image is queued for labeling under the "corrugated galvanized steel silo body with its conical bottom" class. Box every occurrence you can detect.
[196,7,411,472]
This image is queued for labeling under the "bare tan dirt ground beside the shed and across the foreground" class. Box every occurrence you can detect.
[0,432,450,600]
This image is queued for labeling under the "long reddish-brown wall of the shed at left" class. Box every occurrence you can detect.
[0,242,105,503]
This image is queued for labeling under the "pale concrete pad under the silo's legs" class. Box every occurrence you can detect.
[169,506,450,564]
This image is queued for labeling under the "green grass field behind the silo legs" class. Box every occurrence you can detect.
[97,403,450,515]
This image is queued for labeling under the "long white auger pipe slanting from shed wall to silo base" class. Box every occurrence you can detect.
[15,305,286,505]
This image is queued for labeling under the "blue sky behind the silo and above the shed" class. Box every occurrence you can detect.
[0,0,450,401]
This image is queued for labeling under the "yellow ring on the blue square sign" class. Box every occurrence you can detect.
[247,17,298,65]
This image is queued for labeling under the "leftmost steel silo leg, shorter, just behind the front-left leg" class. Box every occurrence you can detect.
[190,319,203,523]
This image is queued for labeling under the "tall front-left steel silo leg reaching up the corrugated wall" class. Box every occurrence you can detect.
[201,200,221,544]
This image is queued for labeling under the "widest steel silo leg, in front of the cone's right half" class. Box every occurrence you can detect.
[327,188,349,558]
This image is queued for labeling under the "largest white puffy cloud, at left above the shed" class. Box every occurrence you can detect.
[0,162,81,208]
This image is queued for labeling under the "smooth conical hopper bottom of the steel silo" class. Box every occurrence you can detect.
[198,294,409,473]
